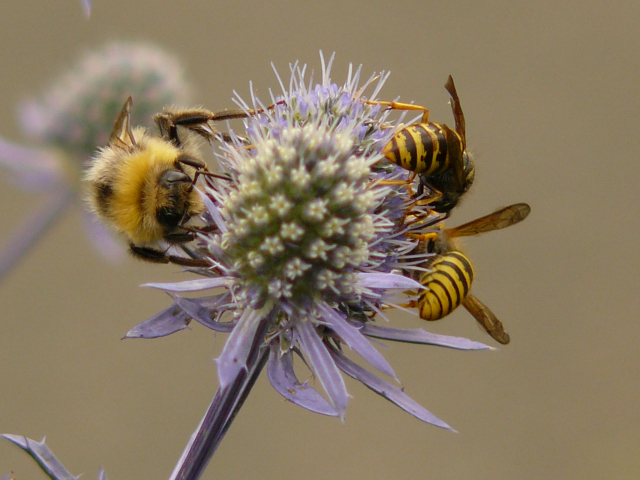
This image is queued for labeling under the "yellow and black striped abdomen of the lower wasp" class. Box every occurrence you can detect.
[418,250,473,320]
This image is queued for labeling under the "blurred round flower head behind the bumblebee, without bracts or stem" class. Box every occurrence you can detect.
[20,42,190,161]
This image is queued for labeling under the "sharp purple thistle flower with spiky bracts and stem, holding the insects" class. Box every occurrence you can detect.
[127,53,489,478]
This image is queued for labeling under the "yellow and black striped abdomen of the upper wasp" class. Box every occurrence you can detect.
[382,123,455,175]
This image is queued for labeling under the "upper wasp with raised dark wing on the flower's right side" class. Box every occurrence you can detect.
[364,75,475,217]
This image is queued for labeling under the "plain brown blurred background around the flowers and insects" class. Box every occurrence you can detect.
[0,0,640,480]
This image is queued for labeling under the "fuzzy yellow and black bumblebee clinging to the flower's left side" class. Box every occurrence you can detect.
[85,97,247,266]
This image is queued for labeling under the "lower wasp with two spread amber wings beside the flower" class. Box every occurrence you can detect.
[411,203,531,344]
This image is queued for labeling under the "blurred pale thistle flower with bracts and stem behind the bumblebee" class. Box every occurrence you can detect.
[0,43,189,277]
